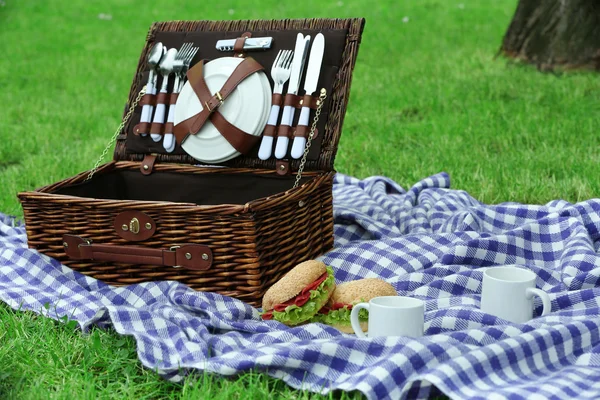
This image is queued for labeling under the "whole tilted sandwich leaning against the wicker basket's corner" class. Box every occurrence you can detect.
[261,260,335,326]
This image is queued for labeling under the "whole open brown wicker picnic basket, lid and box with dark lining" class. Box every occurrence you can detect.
[18,19,364,305]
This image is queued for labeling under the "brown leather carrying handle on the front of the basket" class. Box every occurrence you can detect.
[63,235,213,271]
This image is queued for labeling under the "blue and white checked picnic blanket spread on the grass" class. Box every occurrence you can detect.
[0,173,600,399]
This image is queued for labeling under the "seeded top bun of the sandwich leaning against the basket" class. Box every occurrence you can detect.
[262,260,327,311]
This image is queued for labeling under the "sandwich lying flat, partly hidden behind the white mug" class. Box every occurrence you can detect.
[310,278,398,333]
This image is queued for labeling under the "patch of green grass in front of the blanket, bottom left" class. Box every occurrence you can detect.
[0,305,360,400]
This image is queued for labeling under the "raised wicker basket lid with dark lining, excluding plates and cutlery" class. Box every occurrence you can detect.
[114,18,365,171]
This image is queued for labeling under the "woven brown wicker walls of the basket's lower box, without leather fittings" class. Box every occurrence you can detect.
[19,162,333,306]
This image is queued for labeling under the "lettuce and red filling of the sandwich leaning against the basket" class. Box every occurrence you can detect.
[261,267,335,325]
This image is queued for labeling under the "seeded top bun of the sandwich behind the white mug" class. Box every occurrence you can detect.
[329,278,398,305]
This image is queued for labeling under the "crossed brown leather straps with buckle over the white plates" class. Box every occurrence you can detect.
[173,57,263,154]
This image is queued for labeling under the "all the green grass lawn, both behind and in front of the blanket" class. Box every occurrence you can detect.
[0,0,600,399]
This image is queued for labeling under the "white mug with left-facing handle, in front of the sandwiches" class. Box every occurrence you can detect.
[350,296,425,338]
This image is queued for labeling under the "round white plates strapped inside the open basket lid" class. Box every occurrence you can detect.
[174,57,272,163]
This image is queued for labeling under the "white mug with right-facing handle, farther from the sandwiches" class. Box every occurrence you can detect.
[481,265,552,324]
